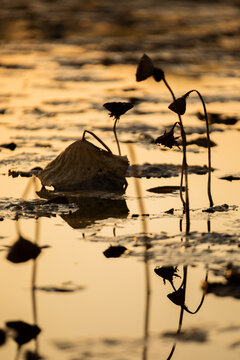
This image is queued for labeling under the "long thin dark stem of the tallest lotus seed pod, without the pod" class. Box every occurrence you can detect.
[163,77,190,233]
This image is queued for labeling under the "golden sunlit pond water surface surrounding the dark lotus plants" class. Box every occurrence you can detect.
[0,0,240,360]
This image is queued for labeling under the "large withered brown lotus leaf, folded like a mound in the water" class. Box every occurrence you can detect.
[37,138,129,191]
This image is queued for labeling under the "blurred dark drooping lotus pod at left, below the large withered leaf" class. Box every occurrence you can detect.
[7,236,41,264]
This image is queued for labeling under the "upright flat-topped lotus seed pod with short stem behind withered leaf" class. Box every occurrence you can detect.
[103,102,133,155]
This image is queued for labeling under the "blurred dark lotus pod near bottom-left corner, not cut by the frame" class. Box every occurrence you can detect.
[6,321,41,346]
